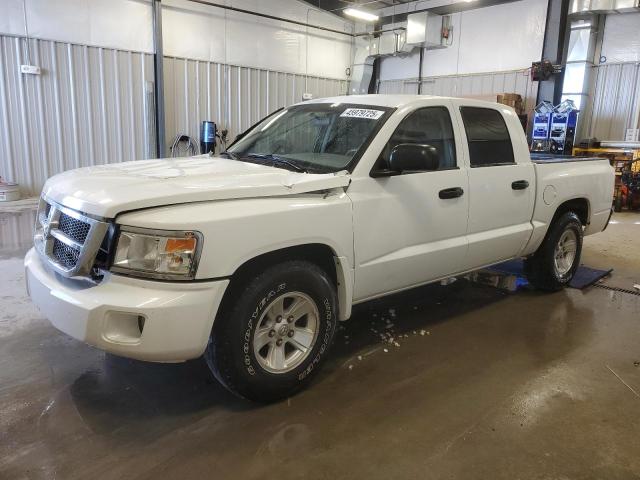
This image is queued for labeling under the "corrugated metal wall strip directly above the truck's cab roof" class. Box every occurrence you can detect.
[378,69,538,109]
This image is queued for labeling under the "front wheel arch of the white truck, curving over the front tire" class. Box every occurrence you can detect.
[223,243,353,320]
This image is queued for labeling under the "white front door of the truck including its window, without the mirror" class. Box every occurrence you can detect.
[348,105,469,301]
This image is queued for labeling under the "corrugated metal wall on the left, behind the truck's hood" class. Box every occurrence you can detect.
[0,36,347,195]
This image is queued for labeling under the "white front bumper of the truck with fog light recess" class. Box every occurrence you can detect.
[25,248,229,362]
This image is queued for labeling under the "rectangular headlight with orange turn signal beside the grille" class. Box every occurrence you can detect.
[111,227,202,280]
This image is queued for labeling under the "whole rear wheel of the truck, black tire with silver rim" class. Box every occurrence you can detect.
[524,212,583,292]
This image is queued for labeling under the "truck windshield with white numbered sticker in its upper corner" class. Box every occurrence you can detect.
[227,103,391,171]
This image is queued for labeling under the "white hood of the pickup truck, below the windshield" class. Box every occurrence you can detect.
[43,155,349,218]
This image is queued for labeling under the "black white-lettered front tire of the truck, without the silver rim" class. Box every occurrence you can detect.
[205,261,337,403]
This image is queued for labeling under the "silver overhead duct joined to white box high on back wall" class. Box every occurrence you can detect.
[349,12,451,95]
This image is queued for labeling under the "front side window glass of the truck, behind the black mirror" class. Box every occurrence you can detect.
[375,107,457,170]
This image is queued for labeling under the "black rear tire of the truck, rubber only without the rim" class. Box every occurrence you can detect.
[524,212,583,292]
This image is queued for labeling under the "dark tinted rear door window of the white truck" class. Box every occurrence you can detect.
[460,107,515,167]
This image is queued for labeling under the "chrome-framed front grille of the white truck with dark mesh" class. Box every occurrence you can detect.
[34,198,109,277]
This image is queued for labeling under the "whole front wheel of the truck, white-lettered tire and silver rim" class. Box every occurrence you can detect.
[205,261,337,402]
